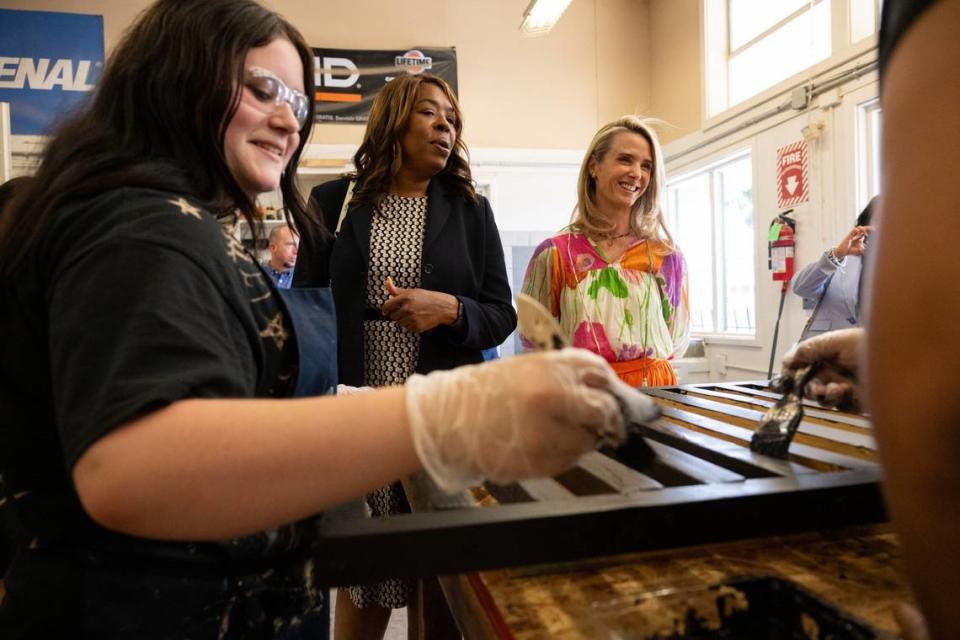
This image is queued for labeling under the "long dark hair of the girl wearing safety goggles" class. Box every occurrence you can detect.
[0,0,314,275]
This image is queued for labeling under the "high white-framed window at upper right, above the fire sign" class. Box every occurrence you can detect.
[702,0,882,117]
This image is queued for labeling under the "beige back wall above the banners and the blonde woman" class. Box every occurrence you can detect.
[0,0,656,148]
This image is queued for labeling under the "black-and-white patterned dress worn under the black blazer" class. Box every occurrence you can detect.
[348,194,427,609]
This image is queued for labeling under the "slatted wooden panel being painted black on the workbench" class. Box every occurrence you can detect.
[315,383,886,584]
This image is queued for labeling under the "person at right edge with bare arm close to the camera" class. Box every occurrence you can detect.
[785,0,960,640]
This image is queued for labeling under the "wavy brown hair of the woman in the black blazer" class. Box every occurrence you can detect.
[349,73,477,204]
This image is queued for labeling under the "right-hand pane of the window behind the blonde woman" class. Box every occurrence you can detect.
[716,156,757,334]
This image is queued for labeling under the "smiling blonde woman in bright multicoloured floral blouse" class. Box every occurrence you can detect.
[523,116,689,387]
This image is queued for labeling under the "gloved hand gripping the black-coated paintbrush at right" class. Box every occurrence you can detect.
[783,328,866,411]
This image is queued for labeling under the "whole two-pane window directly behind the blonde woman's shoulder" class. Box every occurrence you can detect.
[667,152,756,336]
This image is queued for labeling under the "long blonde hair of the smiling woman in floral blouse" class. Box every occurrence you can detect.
[570,116,674,250]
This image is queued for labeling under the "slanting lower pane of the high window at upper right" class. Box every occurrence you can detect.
[729,0,830,106]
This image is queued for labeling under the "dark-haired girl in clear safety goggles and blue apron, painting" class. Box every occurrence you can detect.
[0,0,623,640]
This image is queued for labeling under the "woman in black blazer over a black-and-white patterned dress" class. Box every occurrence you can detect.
[294,74,517,637]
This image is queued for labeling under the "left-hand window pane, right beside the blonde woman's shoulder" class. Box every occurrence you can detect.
[670,173,716,333]
